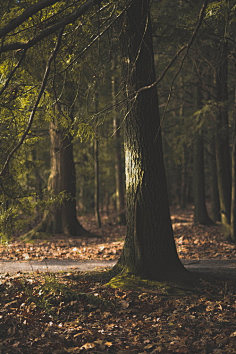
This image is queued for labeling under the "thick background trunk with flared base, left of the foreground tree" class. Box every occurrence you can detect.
[23,109,88,238]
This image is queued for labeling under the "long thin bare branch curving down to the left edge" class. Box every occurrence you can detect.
[0,27,64,178]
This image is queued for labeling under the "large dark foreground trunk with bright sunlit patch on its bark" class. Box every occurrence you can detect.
[116,0,187,280]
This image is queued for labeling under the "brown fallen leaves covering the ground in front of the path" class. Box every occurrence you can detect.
[0,272,236,354]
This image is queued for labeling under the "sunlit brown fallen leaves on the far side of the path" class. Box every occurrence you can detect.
[0,209,236,261]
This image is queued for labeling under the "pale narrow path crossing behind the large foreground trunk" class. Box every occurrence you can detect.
[0,259,236,279]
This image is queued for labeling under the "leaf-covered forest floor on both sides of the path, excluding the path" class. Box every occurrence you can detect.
[0,208,236,354]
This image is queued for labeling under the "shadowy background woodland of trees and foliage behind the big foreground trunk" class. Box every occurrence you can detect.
[0,1,236,241]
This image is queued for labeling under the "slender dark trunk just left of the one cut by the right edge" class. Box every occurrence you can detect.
[215,42,231,237]
